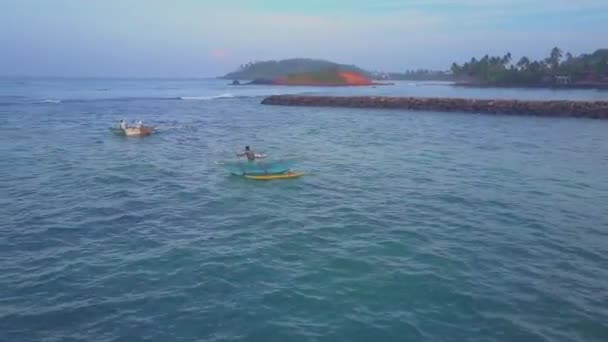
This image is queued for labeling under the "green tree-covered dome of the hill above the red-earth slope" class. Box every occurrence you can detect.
[222,58,369,80]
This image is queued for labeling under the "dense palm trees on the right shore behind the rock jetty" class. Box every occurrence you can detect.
[451,47,608,87]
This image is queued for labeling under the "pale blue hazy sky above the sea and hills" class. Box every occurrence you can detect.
[0,0,608,77]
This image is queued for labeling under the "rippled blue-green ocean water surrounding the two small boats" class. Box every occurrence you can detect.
[0,78,608,342]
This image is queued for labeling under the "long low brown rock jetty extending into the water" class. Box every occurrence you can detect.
[262,95,608,119]
